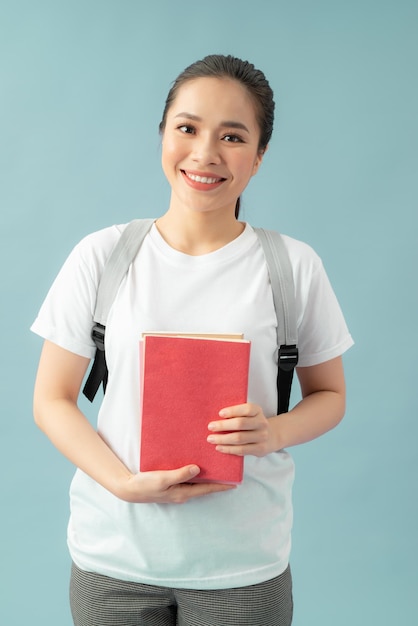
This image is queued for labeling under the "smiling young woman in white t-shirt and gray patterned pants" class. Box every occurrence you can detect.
[32,55,352,626]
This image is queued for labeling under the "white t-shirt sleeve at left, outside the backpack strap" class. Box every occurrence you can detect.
[31,227,119,358]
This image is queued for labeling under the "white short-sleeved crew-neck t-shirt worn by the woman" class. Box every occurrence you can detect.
[32,224,353,589]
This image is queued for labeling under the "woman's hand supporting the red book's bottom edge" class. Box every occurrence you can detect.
[120,465,235,504]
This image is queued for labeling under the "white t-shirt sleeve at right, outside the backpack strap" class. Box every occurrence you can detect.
[289,242,354,367]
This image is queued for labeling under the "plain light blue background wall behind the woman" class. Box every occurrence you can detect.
[0,0,418,626]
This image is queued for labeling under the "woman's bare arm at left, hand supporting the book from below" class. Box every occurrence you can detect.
[34,341,231,503]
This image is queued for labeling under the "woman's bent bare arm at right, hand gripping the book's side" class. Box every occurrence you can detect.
[208,357,345,456]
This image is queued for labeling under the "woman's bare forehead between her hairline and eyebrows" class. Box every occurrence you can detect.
[169,77,257,126]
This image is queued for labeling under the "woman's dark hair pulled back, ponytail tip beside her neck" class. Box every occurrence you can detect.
[159,54,274,218]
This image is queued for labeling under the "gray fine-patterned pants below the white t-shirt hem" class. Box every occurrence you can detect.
[70,564,293,626]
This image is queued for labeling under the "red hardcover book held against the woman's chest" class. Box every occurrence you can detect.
[140,335,250,483]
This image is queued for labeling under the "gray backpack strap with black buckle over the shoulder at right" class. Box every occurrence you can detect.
[254,228,298,414]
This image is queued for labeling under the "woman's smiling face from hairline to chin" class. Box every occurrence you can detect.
[162,78,262,213]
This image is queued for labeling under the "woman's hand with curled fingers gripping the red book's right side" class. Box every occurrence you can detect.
[207,402,276,457]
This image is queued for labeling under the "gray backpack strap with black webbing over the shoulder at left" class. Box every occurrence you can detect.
[83,219,154,402]
